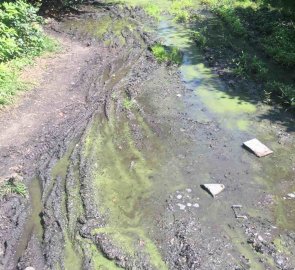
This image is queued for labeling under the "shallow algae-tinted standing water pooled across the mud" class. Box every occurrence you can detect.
[19,3,295,269]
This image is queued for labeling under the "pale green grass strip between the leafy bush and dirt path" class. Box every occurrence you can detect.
[0,37,60,108]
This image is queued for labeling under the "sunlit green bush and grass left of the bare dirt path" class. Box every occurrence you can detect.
[0,0,58,106]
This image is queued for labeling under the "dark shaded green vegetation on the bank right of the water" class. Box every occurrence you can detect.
[192,0,295,107]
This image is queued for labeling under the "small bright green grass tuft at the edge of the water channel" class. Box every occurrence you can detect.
[151,44,182,64]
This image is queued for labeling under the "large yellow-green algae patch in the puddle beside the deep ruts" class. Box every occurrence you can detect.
[84,110,167,269]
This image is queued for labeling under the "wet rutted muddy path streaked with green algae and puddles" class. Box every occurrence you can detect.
[0,4,295,269]
